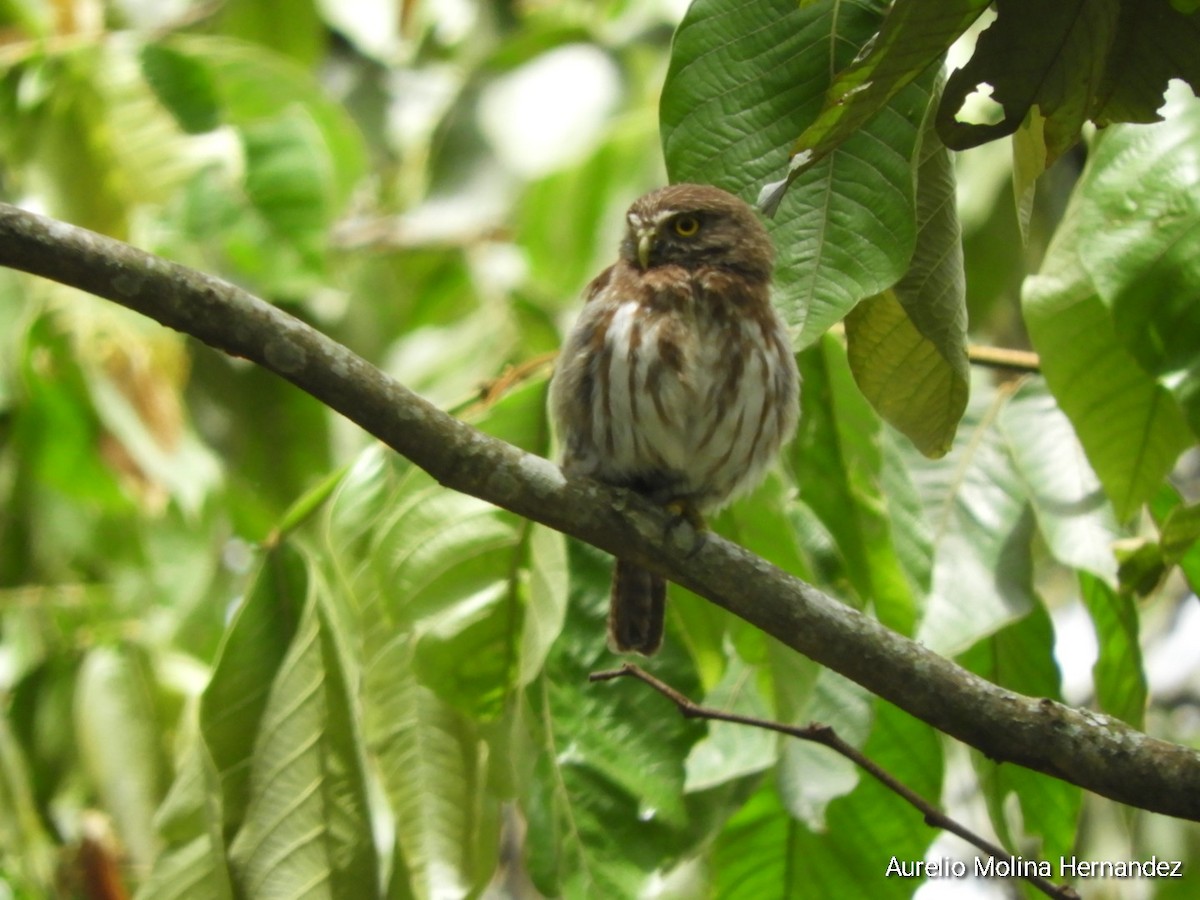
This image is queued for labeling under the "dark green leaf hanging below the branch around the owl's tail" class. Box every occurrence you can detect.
[522,542,713,898]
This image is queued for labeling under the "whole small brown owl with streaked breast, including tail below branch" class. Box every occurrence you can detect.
[550,185,799,655]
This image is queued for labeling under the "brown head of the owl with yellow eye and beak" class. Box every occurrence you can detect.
[620,184,775,280]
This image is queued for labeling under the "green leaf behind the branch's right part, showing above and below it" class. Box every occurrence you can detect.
[959,605,1082,860]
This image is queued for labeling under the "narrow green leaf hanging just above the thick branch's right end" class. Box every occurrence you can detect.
[1079,572,1147,728]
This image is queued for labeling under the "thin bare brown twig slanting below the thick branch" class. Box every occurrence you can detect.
[588,662,1079,900]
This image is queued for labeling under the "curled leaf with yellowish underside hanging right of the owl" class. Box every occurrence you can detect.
[846,110,970,456]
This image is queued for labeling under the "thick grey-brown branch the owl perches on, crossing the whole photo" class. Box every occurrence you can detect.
[0,204,1200,821]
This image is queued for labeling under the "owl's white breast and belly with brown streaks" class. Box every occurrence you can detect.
[557,264,794,508]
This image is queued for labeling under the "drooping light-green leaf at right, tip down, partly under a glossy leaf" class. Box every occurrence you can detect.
[1022,170,1193,522]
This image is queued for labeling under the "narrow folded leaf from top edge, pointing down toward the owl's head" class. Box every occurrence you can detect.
[792,0,991,177]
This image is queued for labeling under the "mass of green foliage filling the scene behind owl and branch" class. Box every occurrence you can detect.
[0,0,1200,898]
